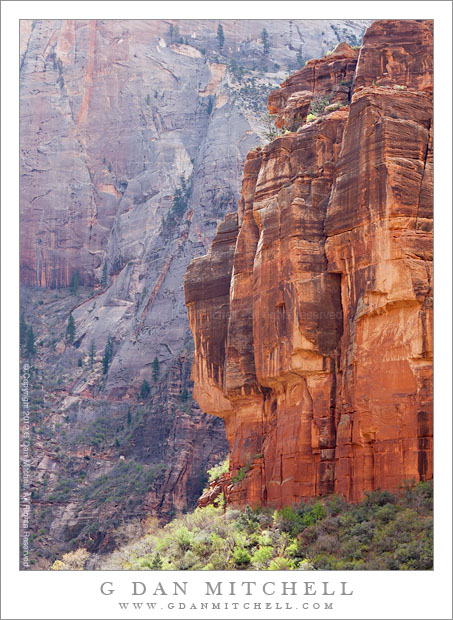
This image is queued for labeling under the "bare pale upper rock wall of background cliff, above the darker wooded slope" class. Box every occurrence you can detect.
[20,20,369,397]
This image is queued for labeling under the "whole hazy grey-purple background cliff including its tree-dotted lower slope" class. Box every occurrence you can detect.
[20,20,369,554]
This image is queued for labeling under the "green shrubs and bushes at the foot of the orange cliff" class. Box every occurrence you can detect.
[62,480,433,570]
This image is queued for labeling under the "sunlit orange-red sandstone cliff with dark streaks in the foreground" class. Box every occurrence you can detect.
[185,21,432,506]
